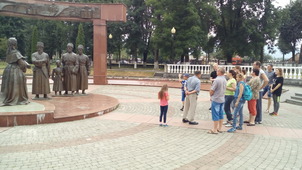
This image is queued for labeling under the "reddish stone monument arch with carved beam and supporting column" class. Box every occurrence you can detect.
[0,0,126,85]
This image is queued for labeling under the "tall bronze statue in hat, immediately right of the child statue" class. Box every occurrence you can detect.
[62,43,79,94]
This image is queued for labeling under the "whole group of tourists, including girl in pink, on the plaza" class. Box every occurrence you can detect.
[158,61,284,134]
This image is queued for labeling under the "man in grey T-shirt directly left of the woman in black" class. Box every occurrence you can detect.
[263,64,276,113]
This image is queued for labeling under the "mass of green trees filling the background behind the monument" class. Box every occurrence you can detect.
[0,0,302,63]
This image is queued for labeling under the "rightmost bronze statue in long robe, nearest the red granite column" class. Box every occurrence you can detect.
[77,45,90,94]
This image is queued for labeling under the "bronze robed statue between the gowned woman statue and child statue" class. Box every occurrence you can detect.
[31,42,50,99]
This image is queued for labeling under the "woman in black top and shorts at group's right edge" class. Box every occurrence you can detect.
[270,68,284,116]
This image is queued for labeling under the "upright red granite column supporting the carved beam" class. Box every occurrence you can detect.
[93,20,108,85]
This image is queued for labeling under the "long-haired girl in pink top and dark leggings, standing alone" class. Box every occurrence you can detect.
[158,84,169,126]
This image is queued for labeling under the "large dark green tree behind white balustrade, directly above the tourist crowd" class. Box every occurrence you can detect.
[216,0,278,62]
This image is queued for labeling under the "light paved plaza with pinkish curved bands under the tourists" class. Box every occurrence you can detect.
[0,85,302,170]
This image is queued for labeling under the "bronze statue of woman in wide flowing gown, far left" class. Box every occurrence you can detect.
[0,38,30,106]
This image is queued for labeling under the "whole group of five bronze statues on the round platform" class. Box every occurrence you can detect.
[0,37,90,106]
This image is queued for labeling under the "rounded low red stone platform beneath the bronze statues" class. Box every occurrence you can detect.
[0,94,119,127]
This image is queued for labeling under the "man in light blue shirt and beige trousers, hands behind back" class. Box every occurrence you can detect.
[182,71,201,125]
